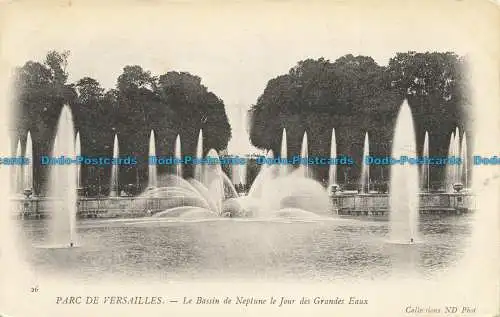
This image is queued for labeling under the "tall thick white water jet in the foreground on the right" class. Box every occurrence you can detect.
[389,100,419,243]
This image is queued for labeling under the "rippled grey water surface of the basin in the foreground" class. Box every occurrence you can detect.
[18,216,471,281]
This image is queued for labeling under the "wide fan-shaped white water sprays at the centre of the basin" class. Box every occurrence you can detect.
[141,123,329,219]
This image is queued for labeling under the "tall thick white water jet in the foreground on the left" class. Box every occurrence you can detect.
[48,105,77,247]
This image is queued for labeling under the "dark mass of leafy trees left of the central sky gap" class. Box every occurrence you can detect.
[11,51,231,194]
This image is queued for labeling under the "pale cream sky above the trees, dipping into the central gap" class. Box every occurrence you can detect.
[1,1,484,153]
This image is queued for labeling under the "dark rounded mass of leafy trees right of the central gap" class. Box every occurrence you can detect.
[250,52,472,188]
